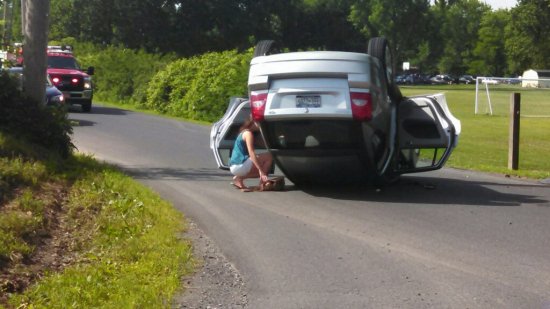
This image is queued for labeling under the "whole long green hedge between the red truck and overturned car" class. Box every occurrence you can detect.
[50,38,252,121]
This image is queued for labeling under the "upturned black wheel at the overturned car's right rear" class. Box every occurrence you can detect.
[367,37,403,102]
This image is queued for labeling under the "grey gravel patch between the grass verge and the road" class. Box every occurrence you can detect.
[172,221,248,309]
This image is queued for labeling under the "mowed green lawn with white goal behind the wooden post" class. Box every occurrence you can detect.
[400,85,550,179]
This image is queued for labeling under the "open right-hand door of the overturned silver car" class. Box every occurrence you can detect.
[393,94,461,174]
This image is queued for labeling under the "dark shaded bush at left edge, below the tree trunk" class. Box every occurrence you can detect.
[0,73,74,157]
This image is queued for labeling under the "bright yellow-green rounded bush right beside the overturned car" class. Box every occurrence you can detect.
[145,50,252,121]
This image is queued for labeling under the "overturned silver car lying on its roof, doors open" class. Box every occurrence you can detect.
[210,38,461,185]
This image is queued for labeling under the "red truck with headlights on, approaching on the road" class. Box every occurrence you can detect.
[47,46,94,112]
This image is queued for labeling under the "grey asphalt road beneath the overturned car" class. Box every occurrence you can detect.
[70,106,550,309]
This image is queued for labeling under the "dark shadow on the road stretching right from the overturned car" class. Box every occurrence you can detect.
[296,177,550,207]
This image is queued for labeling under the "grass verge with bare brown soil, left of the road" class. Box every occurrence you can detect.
[0,133,194,308]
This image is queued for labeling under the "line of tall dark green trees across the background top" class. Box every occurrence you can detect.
[2,0,550,76]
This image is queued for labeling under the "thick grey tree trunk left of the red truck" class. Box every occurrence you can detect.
[21,0,50,103]
